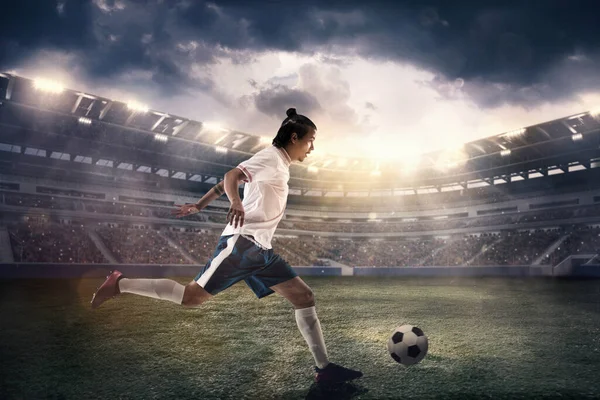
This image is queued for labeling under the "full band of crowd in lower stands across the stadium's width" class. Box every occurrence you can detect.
[7,222,600,267]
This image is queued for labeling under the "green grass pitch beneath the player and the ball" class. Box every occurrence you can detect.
[0,277,600,399]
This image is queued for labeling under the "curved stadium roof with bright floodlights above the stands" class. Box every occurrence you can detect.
[0,73,600,195]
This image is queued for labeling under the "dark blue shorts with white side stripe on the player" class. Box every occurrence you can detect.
[194,234,298,299]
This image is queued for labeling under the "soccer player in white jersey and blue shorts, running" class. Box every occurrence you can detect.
[91,108,362,383]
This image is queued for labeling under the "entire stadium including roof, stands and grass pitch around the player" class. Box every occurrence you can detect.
[0,73,600,399]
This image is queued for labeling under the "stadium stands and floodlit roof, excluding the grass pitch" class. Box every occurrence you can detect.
[0,73,600,276]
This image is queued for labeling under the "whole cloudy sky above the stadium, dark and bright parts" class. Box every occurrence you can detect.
[0,0,600,160]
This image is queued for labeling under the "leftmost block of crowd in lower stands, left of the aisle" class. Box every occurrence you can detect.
[7,222,107,263]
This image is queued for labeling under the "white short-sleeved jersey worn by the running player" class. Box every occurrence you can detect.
[221,146,292,249]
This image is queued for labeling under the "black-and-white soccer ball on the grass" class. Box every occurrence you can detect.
[388,325,429,365]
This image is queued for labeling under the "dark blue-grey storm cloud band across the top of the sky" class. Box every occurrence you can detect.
[0,0,600,106]
